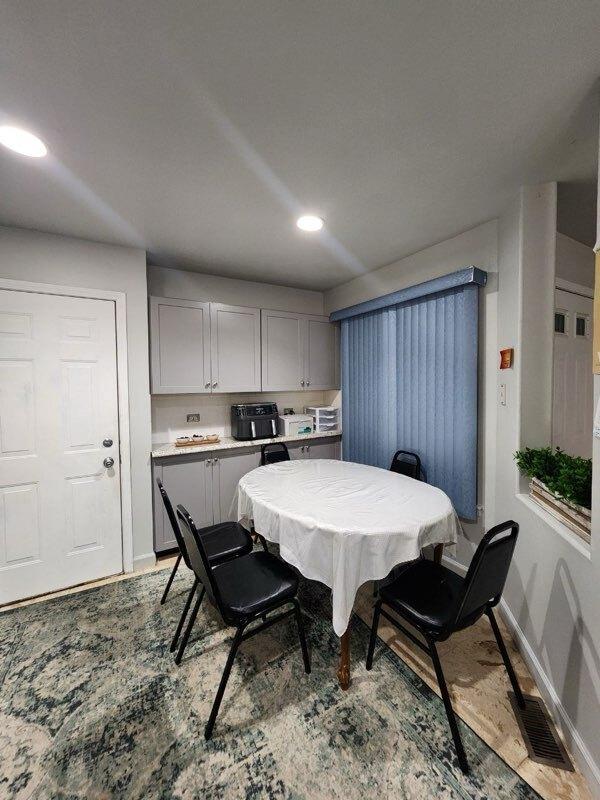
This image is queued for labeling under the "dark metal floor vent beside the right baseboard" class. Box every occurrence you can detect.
[508,692,575,772]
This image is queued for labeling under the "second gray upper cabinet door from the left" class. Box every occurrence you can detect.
[210,303,260,392]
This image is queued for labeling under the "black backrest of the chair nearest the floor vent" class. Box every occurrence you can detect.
[453,520,519,629]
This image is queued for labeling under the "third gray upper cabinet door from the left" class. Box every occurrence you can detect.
[261,309,305,392]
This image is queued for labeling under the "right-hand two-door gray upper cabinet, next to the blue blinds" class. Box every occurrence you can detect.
[261,309,337,391]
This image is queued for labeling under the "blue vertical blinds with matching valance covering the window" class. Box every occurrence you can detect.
[332,270,485,519]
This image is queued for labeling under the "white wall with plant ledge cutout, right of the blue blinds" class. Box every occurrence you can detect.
[496,184,600,796]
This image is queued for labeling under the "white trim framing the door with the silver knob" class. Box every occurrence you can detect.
[0,278,134,572]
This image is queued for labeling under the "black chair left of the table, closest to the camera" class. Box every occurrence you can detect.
[177,505,310,739]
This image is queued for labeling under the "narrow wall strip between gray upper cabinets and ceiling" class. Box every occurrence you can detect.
[148,266,323,314]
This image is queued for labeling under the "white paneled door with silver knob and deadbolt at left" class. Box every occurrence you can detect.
[0,290,123,603]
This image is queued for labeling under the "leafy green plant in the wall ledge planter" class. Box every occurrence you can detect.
[515,447,592,508]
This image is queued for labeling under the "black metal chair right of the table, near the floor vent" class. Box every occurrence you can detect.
[366,520,525,772]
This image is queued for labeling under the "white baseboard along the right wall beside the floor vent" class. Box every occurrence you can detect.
[442,556,600,797]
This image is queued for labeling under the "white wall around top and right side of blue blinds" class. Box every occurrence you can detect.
[325,220,499,565]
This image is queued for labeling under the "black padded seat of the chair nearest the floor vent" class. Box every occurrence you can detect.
[380,559,464,636]
